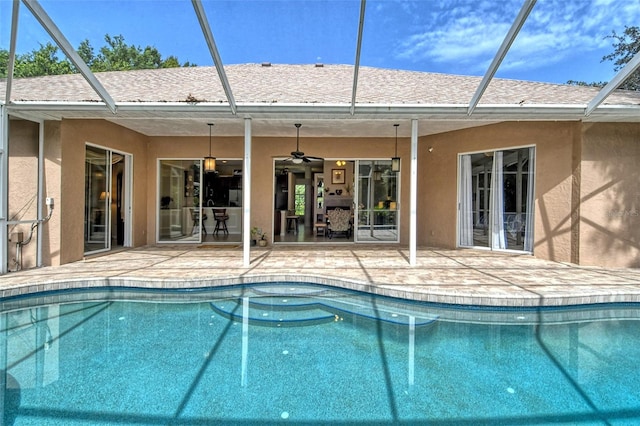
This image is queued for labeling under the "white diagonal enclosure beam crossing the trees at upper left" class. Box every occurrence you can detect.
[22,0,116,114]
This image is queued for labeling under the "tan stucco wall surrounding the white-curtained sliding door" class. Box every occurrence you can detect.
[418,122,580,262]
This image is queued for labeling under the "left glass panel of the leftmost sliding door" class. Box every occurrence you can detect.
[84,146,111,253]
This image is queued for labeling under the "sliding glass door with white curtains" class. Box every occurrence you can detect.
[458,147,535,252]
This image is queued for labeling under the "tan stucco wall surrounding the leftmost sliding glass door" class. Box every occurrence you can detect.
[60,120,149,263]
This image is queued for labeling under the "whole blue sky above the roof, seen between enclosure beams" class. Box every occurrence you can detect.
[0,0,640,83]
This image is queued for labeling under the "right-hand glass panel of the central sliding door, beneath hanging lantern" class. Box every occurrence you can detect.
[354,160,400,242]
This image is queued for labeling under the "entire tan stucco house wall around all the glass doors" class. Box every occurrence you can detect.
[9,115,640,267]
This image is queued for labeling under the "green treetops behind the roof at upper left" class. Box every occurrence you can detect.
[0,34,194,78]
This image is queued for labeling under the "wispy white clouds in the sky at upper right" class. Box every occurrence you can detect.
[396,0,640,72]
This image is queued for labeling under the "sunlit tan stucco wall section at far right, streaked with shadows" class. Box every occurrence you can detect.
[579,123,640,268]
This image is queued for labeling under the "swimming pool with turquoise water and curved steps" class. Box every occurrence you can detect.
[0,283,640,425]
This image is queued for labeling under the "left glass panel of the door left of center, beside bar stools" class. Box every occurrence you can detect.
[158,160,201,242]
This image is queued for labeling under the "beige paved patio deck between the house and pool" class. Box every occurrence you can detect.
[0,245,640,307]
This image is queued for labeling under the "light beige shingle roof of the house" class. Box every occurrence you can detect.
[0,64,640,105]
